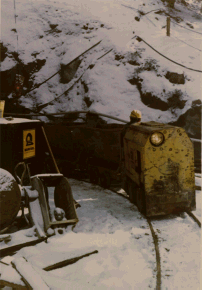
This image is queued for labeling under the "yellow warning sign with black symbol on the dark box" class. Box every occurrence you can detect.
[23,130,35,159]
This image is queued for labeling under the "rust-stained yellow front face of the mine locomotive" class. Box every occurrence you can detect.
[144,127,195,215]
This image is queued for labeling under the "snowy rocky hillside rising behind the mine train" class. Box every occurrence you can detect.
[1,0,202,136]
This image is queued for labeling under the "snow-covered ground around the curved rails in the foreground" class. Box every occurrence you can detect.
[1,175,201,290]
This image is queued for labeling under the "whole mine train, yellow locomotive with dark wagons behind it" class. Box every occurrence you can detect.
[45,115,195,216]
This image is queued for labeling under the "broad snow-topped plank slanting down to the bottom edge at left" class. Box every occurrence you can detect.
[11,257,50,290]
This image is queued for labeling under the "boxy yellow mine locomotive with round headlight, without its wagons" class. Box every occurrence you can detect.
[123,121,196,216]
